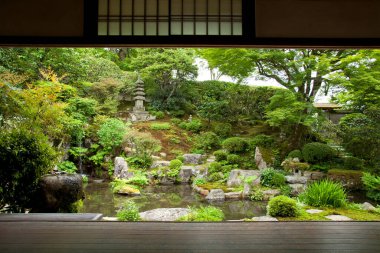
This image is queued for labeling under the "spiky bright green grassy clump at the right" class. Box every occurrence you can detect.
[299,180,347,208]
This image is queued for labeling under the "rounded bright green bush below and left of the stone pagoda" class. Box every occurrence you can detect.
[98,118,127,151]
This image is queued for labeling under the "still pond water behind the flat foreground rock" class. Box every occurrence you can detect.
[80,183,267,220]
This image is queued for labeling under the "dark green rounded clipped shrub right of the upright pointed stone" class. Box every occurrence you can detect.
[302,142,335,163]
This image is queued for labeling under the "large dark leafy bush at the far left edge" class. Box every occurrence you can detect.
[0,128,57,212]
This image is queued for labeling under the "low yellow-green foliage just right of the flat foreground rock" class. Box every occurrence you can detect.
[179,206,224,222]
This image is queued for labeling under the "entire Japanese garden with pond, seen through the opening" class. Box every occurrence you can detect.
[0,48,380,222]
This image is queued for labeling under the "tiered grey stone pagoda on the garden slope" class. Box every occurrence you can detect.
[129,76,156,122]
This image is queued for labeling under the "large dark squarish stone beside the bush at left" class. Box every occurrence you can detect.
[33,174,84,212]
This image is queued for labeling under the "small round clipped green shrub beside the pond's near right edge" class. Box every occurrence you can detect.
[268,196,298,217]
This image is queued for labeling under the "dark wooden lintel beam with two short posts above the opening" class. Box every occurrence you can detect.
[0,0,380,48]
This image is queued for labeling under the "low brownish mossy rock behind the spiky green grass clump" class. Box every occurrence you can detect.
[327,169,363,190]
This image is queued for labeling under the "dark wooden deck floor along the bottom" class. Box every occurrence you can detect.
[0,221,380,253]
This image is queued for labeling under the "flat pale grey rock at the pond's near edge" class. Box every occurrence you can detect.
[140,208,190,221]
